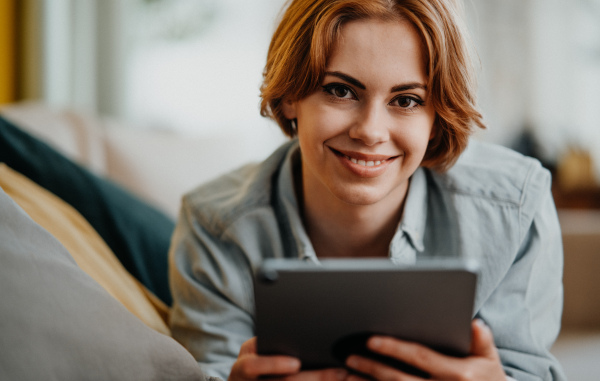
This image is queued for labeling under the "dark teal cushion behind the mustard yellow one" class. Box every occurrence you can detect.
[0,117,174,305]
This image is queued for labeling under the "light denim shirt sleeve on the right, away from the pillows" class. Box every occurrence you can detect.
[477,168,566,381]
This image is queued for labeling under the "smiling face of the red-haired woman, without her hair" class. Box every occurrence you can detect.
[283,20,435,205]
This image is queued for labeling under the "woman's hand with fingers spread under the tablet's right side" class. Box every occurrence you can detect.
[346,320,507,381]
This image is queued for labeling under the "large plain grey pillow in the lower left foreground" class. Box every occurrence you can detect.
[0,188,213,380]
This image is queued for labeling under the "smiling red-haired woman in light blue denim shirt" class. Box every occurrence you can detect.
[170,0,563,380]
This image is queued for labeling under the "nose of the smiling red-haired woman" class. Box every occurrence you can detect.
[349,105,390,146]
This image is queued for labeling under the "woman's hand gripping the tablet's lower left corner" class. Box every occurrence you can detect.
[229,337,348,381]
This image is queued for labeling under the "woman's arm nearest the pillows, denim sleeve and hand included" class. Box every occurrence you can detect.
[170,208,347,381]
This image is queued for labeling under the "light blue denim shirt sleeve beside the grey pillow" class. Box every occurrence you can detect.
[169,200,254,380]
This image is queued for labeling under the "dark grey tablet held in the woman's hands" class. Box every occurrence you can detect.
[254,259,477,374]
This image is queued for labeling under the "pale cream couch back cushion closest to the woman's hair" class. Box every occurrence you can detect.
[103,121,285,218]
